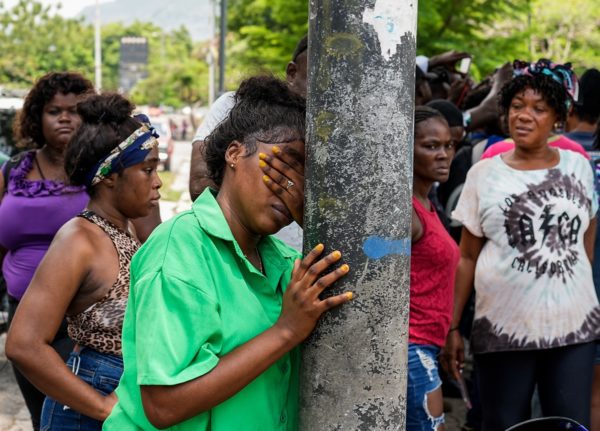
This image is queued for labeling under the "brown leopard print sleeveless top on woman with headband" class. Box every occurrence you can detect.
[67,211,140,356]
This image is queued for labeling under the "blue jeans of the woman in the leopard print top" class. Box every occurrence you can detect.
[40,347,123,431]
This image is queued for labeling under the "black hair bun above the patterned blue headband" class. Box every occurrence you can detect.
[77,93,135,124]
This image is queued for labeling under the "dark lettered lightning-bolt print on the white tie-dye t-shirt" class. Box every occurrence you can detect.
[500,169,591,283]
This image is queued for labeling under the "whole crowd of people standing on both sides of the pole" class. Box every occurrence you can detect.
[0,32,600,431]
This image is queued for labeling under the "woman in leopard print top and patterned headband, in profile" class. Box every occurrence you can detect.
[6,94,162,430]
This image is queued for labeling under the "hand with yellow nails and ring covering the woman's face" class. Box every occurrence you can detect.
[258,146,304,226]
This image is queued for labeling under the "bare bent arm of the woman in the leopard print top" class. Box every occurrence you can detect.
[6,221,116,420]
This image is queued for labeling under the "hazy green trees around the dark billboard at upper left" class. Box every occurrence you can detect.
[0,0,208,107]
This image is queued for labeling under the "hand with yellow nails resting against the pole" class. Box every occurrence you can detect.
[276,244,352,344]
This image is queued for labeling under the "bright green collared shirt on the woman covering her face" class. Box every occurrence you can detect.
[103,189,299,431]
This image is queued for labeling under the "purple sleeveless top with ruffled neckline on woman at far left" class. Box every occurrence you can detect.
[0,151,89,300]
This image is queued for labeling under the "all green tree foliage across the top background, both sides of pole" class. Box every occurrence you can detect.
[0,0,600,107]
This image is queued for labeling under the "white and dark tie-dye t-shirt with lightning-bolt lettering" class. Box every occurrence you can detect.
[452,150,600,353]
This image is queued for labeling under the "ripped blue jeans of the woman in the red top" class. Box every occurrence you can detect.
[406,343,444,431]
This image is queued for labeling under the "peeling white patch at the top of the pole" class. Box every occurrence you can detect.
[363,0,417,60]
